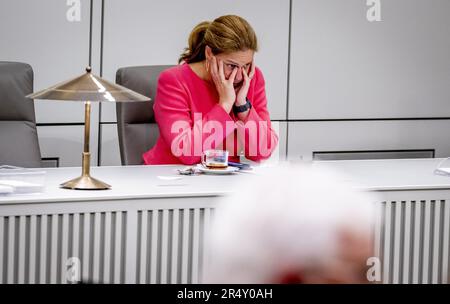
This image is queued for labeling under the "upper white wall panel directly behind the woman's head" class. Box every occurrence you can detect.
[102,0,289,122]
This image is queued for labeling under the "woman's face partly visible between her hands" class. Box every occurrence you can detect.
[206,50,255,87]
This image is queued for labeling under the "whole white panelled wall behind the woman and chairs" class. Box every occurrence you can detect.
[0,0,450,166]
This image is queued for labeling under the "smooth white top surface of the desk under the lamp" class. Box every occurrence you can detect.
[0,159,450,204]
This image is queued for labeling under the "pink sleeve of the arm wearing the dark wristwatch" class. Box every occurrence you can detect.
[237,68,278,161]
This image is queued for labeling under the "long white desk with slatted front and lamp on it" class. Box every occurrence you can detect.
[0,159,450,283]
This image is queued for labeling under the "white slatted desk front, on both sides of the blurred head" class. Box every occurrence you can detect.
[0,200,450,283]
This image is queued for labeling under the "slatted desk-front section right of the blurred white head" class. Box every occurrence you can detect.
[376,200,450,284]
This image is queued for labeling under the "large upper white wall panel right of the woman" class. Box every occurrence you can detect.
[289,0,450,119]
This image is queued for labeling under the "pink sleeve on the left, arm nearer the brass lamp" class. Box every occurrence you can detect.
[154,72,234,165]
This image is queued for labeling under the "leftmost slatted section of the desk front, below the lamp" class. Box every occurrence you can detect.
[0,212,126,283]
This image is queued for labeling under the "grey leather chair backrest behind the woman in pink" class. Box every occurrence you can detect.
[116,65,172,165]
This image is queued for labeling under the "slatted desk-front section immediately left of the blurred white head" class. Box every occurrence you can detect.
[136,208,213,283]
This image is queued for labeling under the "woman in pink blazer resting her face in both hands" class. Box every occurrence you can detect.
[143,15,278,165]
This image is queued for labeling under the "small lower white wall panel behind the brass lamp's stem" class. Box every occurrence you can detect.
[37,123,98,166]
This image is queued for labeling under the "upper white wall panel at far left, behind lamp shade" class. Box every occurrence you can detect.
[0,0,98,123]
